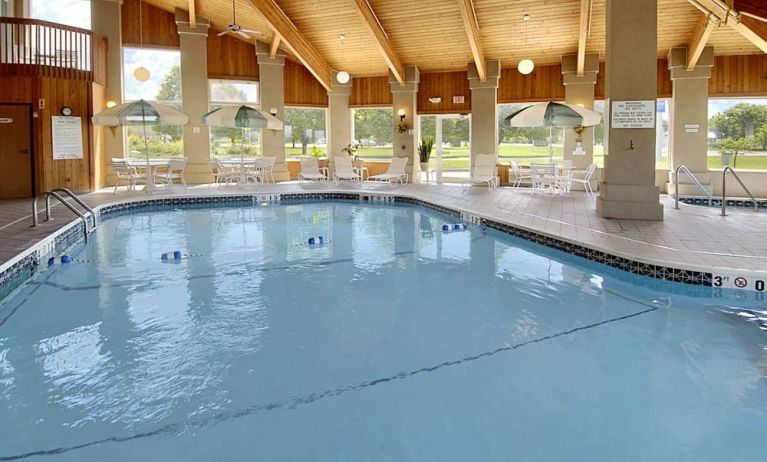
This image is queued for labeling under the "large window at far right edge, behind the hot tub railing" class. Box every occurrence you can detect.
[708,98,767,170]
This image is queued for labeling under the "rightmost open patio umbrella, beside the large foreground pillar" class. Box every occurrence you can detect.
[505,101,602,162]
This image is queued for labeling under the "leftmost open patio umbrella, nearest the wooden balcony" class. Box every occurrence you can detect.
[92,99,189,189]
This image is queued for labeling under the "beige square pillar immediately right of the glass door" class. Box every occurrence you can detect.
[468,60,501,165]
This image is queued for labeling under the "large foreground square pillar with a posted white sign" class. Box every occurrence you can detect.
[597,0,663,220]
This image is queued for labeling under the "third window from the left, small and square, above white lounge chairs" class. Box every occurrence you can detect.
[285,107,328,157]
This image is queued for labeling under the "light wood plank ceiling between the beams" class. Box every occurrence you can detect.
[144,0,761,77]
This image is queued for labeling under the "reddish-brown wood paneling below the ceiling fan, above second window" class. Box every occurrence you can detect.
[208,33,258,80]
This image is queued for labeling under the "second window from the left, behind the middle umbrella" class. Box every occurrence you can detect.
[208,80,261,157]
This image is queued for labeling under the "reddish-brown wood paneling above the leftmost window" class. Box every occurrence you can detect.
[122,0,181,48]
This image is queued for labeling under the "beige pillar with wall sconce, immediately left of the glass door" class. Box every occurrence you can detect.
[389,66,421,182]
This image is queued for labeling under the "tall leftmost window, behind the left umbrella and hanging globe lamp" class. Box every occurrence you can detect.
[123,48,184,157]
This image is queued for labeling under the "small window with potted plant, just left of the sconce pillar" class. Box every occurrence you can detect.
[352,107,394,160]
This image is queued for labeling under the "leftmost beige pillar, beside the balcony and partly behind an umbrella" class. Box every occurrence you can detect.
[92,0,125,188]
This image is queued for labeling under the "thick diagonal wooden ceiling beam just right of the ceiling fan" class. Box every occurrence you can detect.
[250,0,331,91]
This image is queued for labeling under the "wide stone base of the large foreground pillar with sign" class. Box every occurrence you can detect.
[597,183,663,221]
